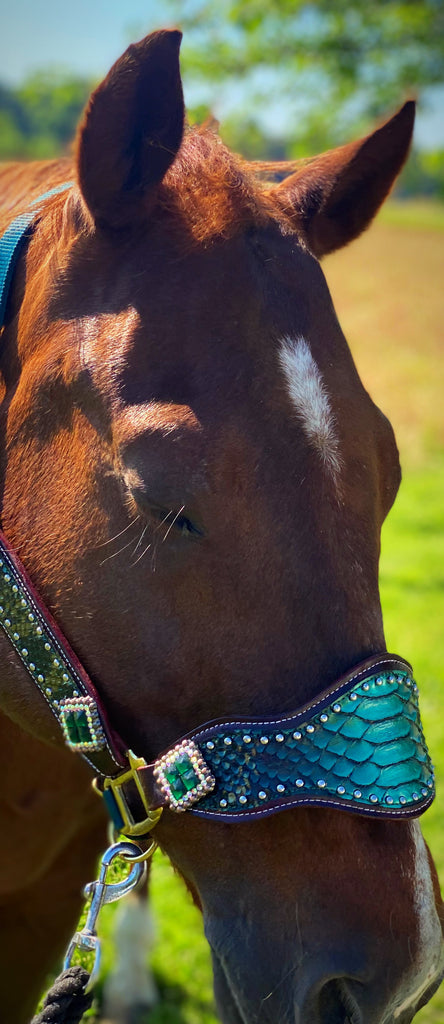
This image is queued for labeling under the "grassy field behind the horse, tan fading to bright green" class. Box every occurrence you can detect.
[41,197,444,1024]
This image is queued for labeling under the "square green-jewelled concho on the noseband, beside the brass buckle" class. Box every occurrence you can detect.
[154,739,216,811]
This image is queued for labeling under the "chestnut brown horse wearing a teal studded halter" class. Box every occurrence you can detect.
[0,30,443,1024]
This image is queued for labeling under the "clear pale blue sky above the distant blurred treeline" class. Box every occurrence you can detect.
[0,0,444,148]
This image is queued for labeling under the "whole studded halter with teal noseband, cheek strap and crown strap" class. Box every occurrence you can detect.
[0,182,435,837]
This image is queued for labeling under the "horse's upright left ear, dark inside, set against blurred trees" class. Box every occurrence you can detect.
[77,31,185,228]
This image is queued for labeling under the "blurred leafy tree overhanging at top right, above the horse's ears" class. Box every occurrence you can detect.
[160,0,444,156]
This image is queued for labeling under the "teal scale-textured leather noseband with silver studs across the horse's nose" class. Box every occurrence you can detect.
[150,653,435,821]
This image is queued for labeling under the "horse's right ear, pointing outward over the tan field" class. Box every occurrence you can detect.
[273,101,414,259]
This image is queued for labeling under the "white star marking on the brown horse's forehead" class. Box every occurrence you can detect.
[279,338,341,476]
